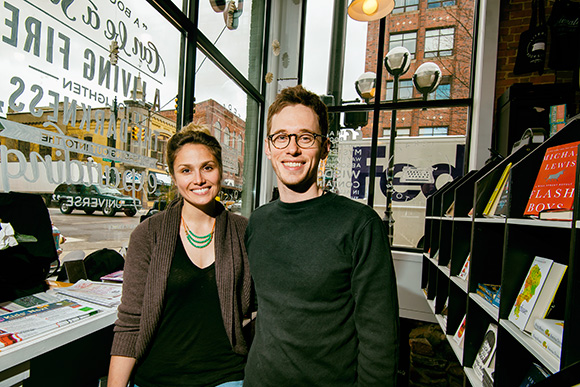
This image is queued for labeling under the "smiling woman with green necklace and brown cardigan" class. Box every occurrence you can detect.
[108,124,252,387]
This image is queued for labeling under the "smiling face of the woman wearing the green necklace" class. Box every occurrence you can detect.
[173,144,222,208]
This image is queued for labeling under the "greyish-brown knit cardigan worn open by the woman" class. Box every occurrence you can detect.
[111,199,252,359]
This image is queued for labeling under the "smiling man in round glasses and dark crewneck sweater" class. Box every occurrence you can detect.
[244,86,399,387]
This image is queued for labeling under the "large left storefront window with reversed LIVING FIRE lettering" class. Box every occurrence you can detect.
[0,0,181,252]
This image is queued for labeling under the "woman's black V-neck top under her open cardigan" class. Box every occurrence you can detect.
[135,238,245,387]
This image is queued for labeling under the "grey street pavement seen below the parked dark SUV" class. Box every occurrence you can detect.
[48,208,146,258]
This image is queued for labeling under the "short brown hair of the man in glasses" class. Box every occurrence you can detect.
[267,85,328,136]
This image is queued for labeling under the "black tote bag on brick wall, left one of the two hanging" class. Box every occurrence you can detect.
[514,0,548,75]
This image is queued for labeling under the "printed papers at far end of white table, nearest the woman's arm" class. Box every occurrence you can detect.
[55,280,123,307]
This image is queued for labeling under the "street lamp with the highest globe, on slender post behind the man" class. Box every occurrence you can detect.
[384,47,411,245]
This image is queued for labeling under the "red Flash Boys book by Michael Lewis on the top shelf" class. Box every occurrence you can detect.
[524,141,580,216]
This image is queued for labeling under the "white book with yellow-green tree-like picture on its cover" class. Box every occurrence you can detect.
[508,257,567,333]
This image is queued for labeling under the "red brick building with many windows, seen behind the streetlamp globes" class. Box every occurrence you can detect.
[363,0,474,137]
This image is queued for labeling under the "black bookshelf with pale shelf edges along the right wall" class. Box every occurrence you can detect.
[421,121,580,387]
